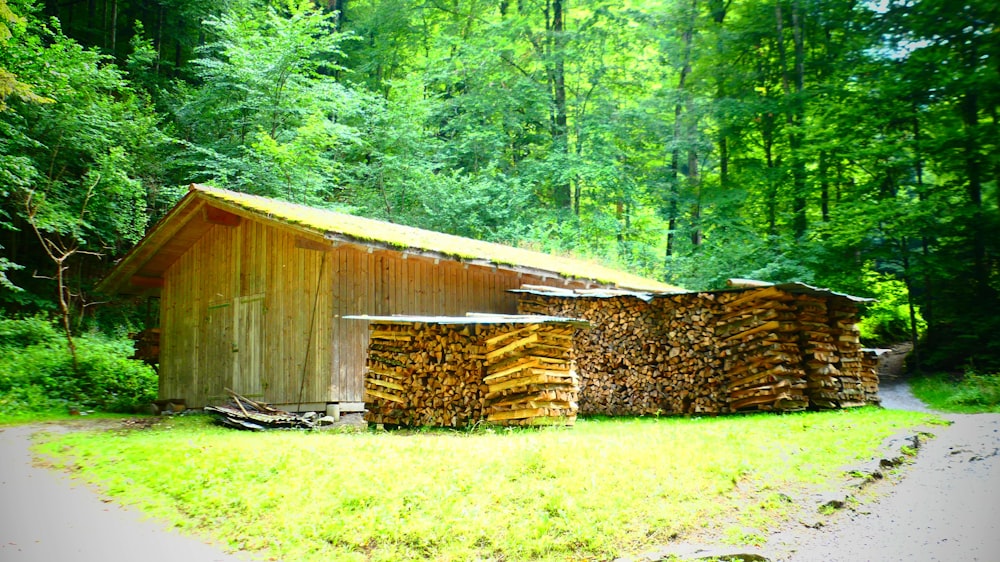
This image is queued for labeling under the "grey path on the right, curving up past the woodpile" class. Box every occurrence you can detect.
[767,346,1000,562]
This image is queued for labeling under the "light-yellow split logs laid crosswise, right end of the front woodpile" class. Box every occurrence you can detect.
[483,324,579,425]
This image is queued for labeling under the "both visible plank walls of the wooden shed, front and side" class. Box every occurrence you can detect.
[159,218,584,407]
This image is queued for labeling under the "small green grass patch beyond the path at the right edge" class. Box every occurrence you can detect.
[910,372,1000,414]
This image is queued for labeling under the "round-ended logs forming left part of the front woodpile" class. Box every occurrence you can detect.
[365,321,486,427]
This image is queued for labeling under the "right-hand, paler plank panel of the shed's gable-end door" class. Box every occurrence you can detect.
[233,294,266,399]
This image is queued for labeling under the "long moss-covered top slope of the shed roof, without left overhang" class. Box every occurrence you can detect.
[191,184,681,291]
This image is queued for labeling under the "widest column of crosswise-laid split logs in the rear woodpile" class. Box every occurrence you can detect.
[716,287,809,411]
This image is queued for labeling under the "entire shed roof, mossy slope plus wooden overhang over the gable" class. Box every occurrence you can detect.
[98,184,680,293]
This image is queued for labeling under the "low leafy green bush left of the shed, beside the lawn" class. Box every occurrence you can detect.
[0,317,157,413]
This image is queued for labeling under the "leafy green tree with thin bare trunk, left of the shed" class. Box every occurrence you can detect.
[0,1,163,314]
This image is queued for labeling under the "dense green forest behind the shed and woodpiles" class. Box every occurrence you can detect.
[0,0,1000,383]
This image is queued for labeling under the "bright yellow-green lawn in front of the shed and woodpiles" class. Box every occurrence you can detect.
[39,408,928,561]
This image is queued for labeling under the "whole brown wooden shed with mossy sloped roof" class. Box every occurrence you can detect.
[98,185,675,411]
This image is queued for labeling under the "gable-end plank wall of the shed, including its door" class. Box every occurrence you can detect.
[160,217,334,406]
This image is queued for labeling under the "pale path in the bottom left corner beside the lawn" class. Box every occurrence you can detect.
[0,425,262,562]
